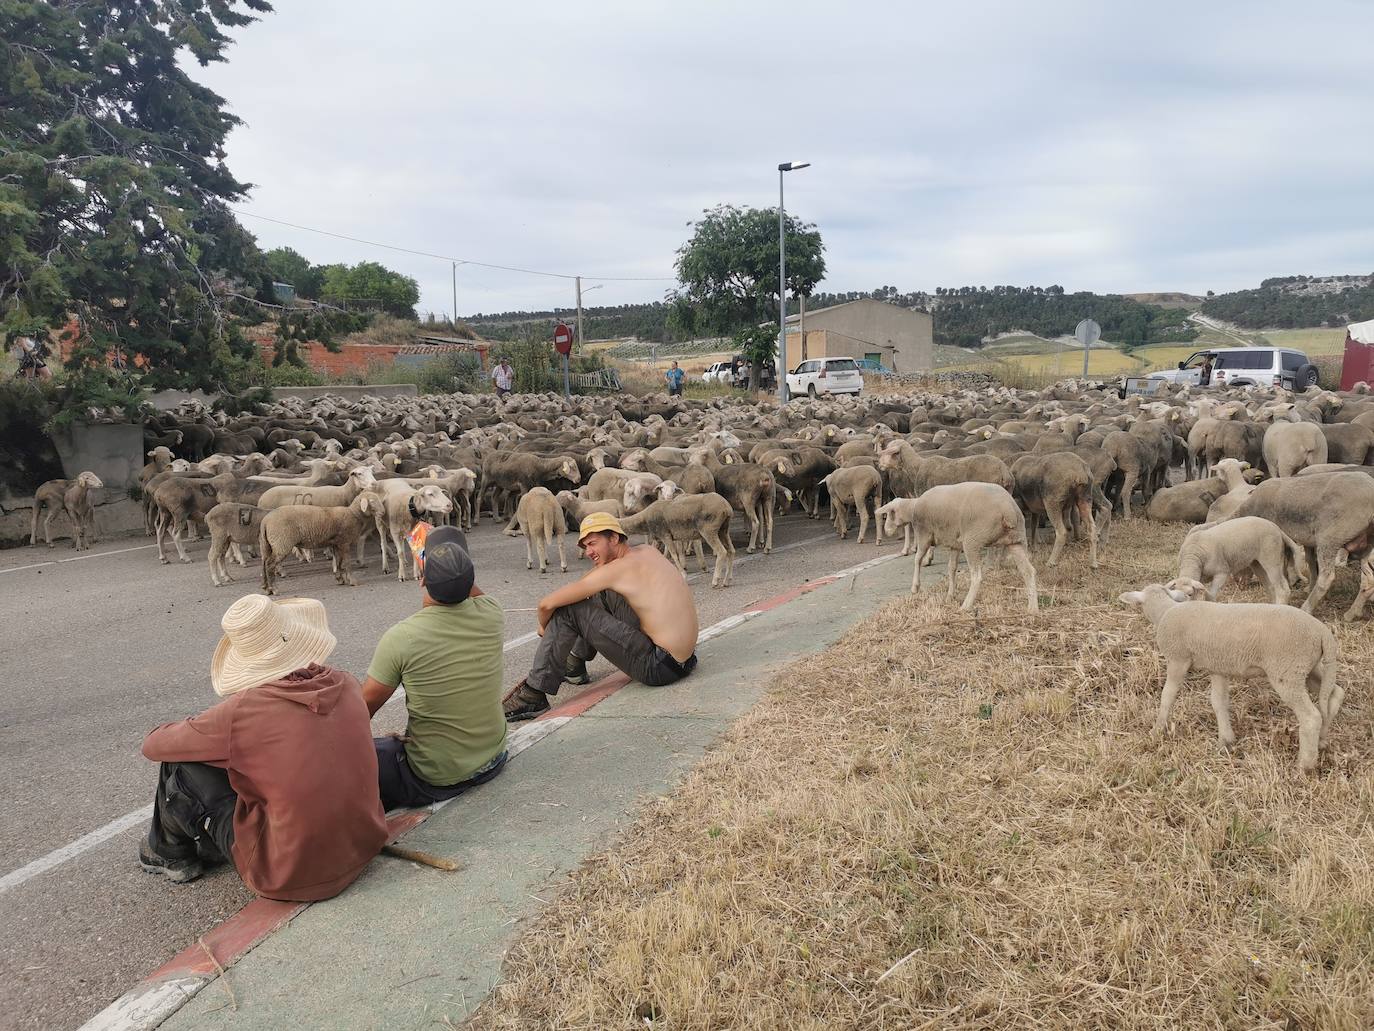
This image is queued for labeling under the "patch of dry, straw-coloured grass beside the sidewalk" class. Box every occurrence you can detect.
[474,521,1374,1031]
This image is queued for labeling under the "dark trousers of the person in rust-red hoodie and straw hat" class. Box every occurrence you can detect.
[148,763,239,863]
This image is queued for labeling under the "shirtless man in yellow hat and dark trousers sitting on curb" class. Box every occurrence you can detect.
[502,513,698,723]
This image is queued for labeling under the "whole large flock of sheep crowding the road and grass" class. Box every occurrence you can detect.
[32,381,1374,771]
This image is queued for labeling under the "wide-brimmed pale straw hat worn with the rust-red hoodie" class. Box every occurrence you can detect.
[210,594,338,697]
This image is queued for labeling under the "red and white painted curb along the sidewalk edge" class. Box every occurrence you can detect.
[80,554,900,1031]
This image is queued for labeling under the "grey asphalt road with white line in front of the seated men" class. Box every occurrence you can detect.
[0,516,900,1030]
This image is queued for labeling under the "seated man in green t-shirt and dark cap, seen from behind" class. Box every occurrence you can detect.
[363,526,506,810]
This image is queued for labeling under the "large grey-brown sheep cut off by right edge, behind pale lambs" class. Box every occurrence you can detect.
[1235,473,1374,621]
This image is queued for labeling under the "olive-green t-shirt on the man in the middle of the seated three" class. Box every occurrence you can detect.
[367,594,506,788]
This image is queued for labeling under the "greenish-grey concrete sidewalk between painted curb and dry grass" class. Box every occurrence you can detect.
[142,558,911,1031]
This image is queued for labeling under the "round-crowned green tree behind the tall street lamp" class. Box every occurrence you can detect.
[671,205,826,388]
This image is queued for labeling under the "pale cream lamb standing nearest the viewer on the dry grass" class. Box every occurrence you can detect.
[1120,585,1345,773]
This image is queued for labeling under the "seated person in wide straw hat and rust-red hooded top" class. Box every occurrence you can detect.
[139,594,387,902]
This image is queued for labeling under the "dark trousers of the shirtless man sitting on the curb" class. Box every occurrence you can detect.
[525,591,697,694]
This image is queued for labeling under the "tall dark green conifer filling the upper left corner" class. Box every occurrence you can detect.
[0,0,272,386]
